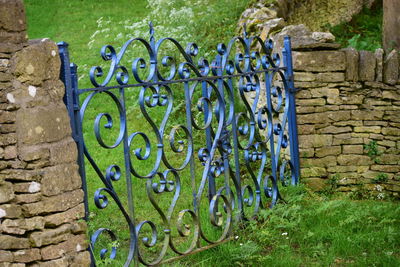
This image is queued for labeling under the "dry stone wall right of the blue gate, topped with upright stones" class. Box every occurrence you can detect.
[282,25,400,198]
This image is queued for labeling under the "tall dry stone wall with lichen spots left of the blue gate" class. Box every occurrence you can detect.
[0,0,90,267]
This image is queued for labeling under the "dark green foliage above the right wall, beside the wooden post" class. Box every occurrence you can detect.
[325,1,383,51]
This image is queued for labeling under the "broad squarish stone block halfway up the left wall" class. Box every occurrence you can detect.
[17,105,71,147]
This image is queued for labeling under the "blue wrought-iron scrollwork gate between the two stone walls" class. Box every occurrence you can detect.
[59,24,299,266]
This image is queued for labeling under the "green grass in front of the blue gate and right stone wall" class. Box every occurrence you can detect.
[176,186,400,267]
